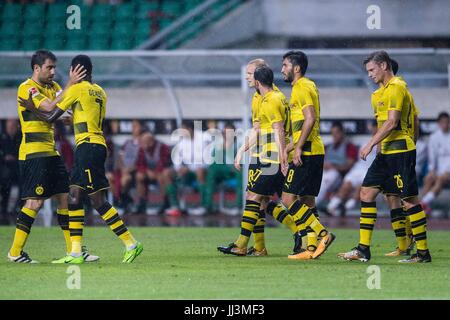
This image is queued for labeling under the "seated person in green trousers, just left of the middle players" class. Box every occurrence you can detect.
[204,123,242,212]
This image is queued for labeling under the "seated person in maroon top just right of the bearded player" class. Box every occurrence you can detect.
[316,121,358,206]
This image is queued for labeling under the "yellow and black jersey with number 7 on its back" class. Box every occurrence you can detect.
[58,81,106,146]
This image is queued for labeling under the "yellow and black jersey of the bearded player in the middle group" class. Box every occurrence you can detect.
[289,77,325,155]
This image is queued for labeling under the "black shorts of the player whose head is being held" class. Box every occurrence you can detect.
[70,142,109,194]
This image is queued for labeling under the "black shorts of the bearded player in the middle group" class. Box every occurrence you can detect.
[283,154,324,197]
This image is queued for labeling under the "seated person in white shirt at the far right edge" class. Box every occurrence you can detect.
[422,112,450,211]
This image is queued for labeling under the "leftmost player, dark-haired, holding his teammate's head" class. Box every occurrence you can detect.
[8,50,98,263]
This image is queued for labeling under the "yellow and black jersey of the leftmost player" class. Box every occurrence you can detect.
[17,79,62,160]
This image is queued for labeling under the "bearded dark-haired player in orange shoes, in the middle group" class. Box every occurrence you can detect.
[281,51,335,260]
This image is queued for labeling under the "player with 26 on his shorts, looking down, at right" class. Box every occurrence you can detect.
[338,51,431,263]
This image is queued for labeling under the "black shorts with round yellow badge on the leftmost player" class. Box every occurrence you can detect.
[19,156,69,199]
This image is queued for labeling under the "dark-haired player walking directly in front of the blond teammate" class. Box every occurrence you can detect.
[217,66,289,256]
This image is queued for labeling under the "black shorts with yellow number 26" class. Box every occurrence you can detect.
[362,150,419,199]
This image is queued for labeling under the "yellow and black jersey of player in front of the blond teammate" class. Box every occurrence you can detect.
[259,90,290,163]
